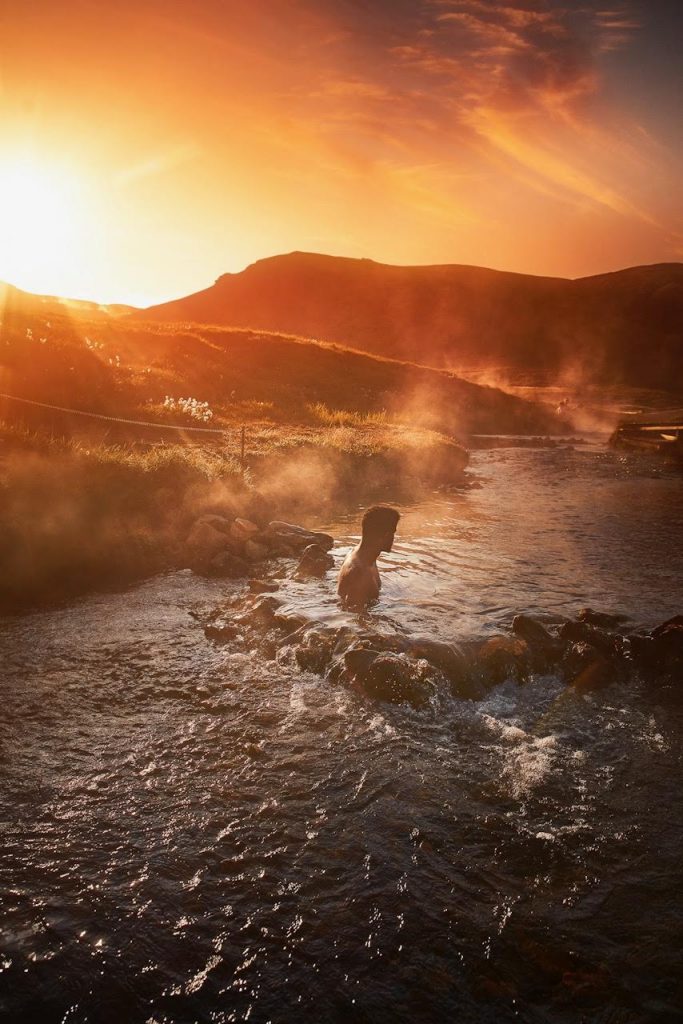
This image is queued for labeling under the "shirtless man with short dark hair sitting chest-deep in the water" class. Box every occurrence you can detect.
[337,505,400,608]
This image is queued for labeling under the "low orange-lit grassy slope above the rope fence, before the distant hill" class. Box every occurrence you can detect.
[0,296,562,438]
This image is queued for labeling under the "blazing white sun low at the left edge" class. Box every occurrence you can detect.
[0,158,86,294]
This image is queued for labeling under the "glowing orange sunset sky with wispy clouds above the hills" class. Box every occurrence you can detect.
[0,0,683,304]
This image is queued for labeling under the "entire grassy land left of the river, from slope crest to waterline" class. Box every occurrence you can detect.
[0,305,562,609]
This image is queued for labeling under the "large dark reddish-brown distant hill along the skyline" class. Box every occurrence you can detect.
[143,253,683,388]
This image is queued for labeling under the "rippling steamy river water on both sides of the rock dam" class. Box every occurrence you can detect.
[0,443,683,1024]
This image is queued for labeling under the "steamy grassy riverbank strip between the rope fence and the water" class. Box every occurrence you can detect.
[0,421,468,612]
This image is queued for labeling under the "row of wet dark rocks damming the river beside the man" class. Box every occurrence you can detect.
[200,598,683,707]
